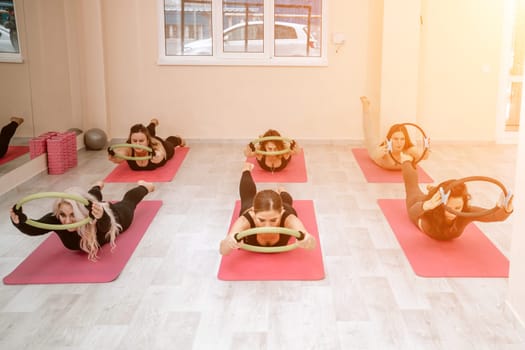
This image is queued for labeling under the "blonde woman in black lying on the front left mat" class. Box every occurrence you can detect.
[11,181,155,261]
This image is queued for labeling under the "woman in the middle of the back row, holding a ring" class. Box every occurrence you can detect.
[244,129,300,172]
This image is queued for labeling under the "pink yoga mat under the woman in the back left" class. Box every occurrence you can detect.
[104,147,190,182]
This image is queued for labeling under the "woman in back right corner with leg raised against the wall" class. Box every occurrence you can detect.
[361,96,428,170]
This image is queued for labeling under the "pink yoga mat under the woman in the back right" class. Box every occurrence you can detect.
[352,148,434,183]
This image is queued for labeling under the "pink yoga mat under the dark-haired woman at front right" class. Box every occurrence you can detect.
[378,199,509,277]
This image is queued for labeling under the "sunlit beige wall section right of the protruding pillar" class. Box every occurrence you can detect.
[418,0,506,141]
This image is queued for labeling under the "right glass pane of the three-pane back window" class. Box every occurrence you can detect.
[274,0,322,57]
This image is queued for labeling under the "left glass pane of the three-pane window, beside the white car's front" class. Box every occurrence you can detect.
[164,0,213,56]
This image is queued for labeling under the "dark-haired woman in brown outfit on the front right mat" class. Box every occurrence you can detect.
[401,153,513,240]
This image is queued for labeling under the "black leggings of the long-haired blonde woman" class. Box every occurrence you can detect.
[89,186,148,232]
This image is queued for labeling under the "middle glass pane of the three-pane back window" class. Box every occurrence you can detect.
[222,0,264,52]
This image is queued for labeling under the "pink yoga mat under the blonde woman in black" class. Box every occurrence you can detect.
[4,200,162,284]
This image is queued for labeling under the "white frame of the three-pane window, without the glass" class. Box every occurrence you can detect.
[157,0,328,66]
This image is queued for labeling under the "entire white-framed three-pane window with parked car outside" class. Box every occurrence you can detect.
[158,0,327,66]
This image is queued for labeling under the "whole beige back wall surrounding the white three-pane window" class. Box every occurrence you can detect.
[0,0,505,141]
